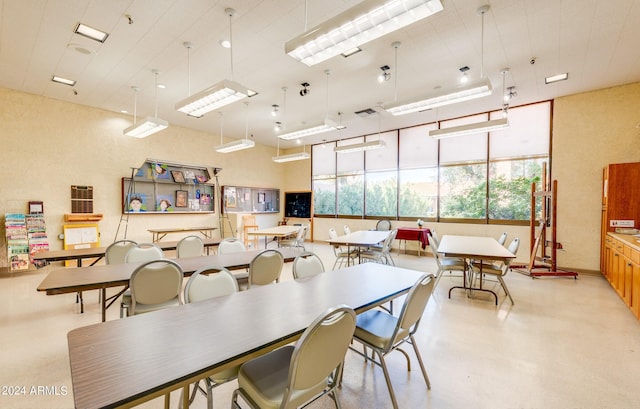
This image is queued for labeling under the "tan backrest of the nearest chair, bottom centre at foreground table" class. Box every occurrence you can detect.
[280,305,356,402]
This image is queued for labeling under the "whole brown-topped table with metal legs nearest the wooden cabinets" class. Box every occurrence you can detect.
[438,235,516,305]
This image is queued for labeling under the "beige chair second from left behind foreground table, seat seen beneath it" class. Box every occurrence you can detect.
[180,266,239,409]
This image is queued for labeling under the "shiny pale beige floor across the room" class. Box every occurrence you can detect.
[0,243,640,409]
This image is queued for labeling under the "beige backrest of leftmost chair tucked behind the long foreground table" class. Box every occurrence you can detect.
[129,259,184,315]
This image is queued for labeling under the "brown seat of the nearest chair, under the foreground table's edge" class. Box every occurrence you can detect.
[238,345,327,409]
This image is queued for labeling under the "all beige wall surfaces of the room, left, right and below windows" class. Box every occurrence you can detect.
[0,83,640,270]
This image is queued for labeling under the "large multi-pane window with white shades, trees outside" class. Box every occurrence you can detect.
[312,102,551,222]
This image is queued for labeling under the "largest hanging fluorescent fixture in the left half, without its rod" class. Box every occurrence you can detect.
[176,80,256,118]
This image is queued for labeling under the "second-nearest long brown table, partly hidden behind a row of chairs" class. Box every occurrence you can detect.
[38,248,300,322]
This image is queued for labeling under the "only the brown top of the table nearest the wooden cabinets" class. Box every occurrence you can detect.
[438,235,516,261]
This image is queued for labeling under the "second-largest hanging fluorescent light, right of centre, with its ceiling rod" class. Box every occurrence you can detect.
[385,4,493,116]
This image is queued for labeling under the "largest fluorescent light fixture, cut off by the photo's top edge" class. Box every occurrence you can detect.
[284,0,443,66]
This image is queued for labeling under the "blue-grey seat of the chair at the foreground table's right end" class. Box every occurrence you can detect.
[354,310,409,349]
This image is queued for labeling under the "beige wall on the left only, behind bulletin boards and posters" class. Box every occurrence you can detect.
[0,88,285,267]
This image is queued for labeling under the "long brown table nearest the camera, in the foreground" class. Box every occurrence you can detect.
[67,263,423,409]
